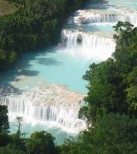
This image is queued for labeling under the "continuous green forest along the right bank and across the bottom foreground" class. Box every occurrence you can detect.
[0,21,137,154]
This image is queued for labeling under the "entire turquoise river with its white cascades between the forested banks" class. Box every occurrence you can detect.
[0,0,137,144]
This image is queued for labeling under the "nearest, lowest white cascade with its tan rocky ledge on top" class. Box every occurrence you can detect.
[1,85,86,133]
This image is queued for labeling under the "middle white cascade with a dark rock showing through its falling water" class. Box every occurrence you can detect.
[62,29,115,60]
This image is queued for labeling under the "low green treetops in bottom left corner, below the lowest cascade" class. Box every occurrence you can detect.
[0,131,58,154]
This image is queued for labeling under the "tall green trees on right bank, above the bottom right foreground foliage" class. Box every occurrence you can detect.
[83,22,137,119]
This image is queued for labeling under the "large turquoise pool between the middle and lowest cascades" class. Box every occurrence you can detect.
[0,48,91,93]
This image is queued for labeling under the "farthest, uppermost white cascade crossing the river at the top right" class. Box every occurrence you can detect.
[68,10,137,25]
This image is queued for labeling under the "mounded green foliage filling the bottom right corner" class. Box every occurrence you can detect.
[80,113,137,154]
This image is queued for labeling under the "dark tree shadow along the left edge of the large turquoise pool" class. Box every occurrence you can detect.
[0,47,58,86]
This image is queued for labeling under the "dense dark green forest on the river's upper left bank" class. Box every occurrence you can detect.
[0,0,86,70]
